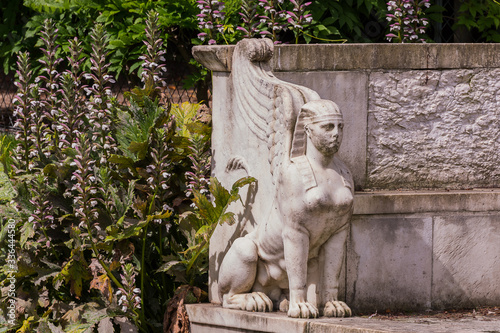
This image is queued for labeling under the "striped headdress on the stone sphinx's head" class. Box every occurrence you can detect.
[290,99,343,190]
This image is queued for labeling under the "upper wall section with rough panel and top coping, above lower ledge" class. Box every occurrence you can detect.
[195,44,500,190]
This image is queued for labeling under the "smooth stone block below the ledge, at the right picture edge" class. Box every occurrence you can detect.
[432,214,500,308]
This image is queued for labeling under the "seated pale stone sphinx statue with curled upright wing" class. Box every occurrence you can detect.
[212,39,354,318]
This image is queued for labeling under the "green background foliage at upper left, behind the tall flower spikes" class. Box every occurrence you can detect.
[0,0,201,74]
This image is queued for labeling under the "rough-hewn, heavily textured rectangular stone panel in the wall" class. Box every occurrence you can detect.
[366,68,500,189]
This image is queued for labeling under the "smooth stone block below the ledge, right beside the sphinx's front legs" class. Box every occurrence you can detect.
[346,215,432,312]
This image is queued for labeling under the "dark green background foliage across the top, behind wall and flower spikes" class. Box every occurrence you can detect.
[0,0,500,91]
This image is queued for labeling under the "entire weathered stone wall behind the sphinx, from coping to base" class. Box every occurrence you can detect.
[194,44,500,312]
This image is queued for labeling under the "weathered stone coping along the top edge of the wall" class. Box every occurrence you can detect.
[193,43,500,72]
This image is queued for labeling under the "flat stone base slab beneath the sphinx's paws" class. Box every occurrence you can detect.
[186,304,500,333]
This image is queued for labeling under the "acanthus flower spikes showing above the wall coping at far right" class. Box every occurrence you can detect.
[386,0,431,43]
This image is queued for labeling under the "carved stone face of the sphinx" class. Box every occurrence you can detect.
[306,119,344,156]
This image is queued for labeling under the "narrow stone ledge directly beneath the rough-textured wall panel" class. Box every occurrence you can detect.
[354,189,500,215]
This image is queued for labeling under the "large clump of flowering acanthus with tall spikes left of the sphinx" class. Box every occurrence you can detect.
[0,12,253,332]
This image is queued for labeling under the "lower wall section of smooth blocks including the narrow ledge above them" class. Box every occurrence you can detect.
[345,190,500,311]
